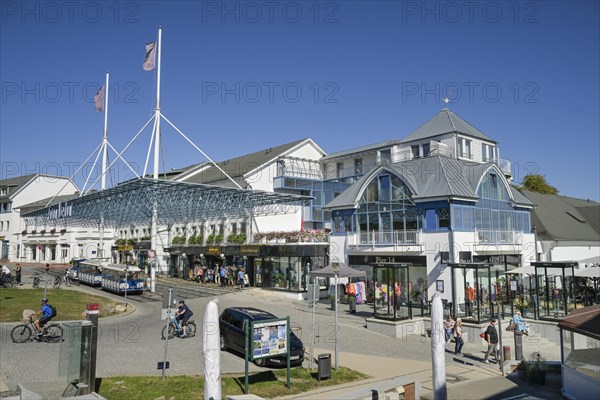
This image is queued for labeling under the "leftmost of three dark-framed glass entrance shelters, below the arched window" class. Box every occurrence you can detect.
[371,262,412,321]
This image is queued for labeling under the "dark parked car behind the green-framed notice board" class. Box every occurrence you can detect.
[219,307,304,367]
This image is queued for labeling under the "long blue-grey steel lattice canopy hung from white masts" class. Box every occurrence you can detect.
[23,178,312,228]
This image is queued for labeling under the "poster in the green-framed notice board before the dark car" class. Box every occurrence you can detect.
[251,319,288,360]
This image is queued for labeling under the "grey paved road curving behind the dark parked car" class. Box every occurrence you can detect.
[0,287,500,384]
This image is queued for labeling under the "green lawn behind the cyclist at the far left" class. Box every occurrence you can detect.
[0,288,124,322]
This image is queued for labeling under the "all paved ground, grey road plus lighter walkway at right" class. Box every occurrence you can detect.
[0,270,564,398]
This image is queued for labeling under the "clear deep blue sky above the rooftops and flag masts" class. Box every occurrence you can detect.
[0,0,600,201]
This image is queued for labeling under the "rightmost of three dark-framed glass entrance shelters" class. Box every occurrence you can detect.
[531,261,578,320]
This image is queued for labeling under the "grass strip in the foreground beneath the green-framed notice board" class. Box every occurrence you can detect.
[96,367,368,400]
